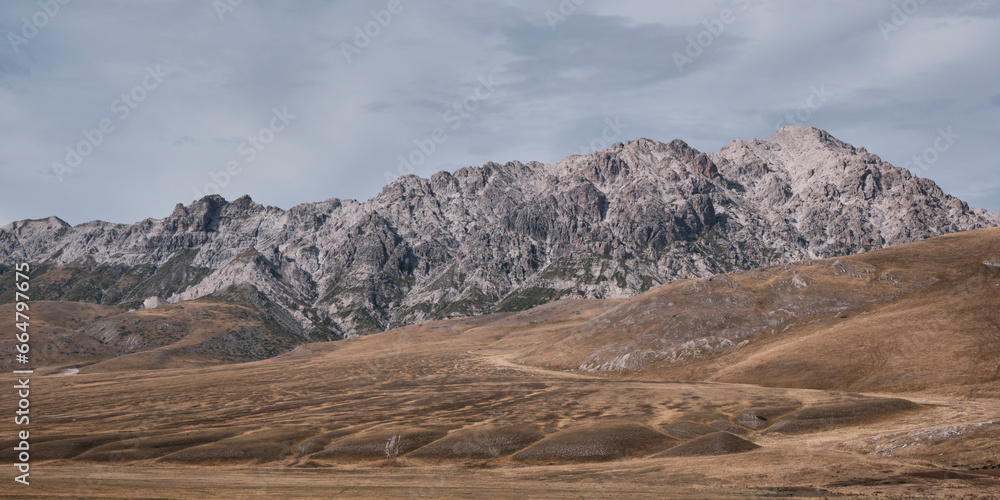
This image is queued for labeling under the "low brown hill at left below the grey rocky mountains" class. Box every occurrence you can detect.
[0,285,311,373]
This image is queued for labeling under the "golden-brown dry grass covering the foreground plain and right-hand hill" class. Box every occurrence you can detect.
[0,230,1000,498]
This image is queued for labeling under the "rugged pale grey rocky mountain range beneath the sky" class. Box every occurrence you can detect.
[0,126,1000,339]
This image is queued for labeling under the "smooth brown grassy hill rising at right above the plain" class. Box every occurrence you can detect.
[503,228,1000,397]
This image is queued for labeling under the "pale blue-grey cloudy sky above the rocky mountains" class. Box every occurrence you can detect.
[0,0,1000,226]
